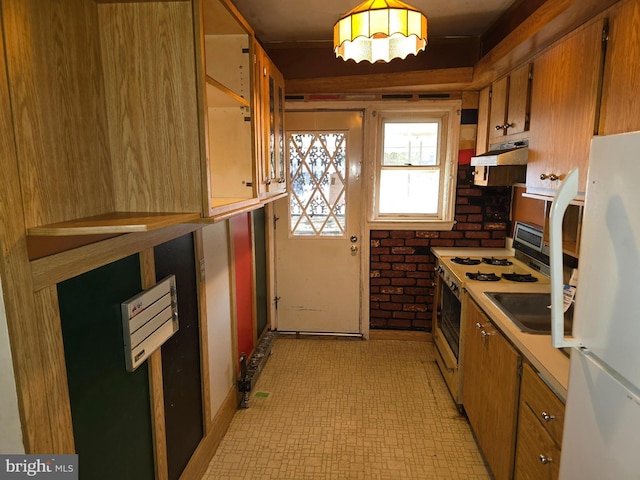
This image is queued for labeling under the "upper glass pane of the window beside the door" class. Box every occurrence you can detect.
[382,122,438,166]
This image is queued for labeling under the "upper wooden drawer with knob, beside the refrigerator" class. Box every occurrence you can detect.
[520,364,564,445]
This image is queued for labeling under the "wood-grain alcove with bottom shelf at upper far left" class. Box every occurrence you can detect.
[1,0,202,235]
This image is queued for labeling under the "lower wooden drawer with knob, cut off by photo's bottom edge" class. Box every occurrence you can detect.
[514,403,560,480]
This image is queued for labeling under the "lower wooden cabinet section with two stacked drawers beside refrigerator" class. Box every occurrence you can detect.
[514,365,564,480]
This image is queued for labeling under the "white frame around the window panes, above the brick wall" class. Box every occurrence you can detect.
[368,100,462,230]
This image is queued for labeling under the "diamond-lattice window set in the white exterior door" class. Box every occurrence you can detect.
[289,132,347,237]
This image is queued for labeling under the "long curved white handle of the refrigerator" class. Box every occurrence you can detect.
[549,167,582,348]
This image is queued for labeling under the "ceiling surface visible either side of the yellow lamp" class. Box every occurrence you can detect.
[232,0,515,43]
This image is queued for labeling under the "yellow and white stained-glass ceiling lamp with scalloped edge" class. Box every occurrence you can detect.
[333,0,427,63]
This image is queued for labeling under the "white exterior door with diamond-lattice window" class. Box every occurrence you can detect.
[275,111,363,334]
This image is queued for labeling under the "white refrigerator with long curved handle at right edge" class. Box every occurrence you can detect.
[550,132,640,480]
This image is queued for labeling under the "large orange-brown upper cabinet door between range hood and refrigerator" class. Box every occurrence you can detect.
[527,20,604,195]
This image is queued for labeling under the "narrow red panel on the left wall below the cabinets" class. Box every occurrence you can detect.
[229,213,253,368]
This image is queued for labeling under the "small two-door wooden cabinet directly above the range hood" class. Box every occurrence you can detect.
[489,64,532,143]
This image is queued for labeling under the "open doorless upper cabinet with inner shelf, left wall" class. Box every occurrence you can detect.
[202,0,258,216]
